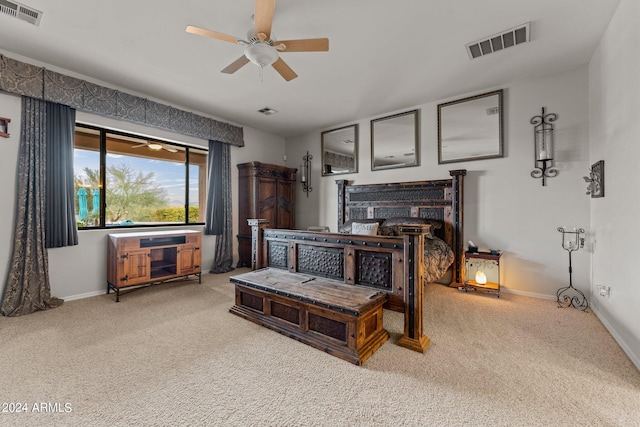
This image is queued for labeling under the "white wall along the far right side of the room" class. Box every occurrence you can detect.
[589,0,640,368]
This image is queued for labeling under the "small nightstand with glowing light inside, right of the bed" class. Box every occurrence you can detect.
[460,251,502,298]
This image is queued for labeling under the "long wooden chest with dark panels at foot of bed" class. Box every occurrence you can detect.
[229,268,389,365]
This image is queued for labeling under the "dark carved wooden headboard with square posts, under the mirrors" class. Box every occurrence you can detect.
[336,169,467,287]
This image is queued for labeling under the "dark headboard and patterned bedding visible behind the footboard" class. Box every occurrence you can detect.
[336,169,467,286]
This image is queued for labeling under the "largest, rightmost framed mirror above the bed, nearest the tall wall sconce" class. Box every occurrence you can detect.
[438,89,504,164]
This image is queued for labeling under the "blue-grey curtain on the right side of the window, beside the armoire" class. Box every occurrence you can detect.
[204,141,233,273]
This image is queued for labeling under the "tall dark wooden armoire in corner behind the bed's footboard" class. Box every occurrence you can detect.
[238,162,296,267]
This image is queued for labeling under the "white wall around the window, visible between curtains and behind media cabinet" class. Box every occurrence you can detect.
[0,86,285,299]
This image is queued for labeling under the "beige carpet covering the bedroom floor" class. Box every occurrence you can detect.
[0,269,640,426]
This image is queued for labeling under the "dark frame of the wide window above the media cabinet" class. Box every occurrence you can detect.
[73,122,209,230]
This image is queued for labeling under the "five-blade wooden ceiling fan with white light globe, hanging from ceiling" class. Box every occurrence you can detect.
[187,0,329,81]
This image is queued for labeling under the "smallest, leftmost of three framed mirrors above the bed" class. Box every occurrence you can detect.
[322,124,358,176]
